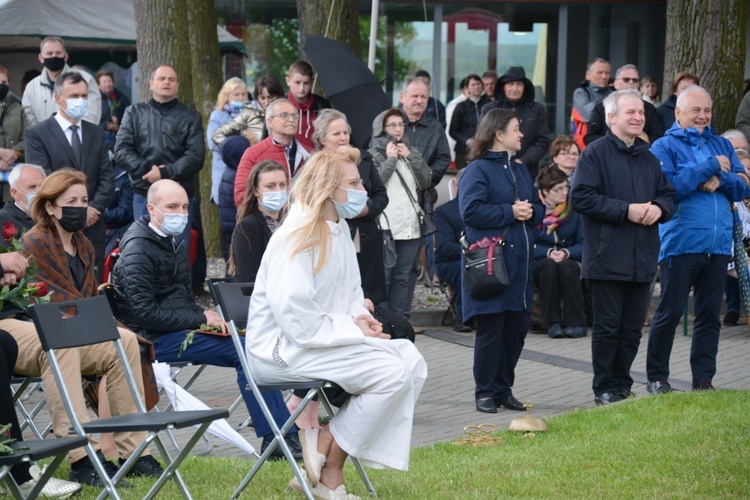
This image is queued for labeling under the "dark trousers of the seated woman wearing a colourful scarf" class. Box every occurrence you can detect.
[534,259,586,327]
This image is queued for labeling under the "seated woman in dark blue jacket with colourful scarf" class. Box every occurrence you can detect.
[534,165,586,339]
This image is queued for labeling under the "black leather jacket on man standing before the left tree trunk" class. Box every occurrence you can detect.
[115,99,206,197]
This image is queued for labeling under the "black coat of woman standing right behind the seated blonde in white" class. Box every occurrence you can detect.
[346,151,388,304]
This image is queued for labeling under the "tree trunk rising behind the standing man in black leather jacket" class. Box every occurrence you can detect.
[134,0,193,106]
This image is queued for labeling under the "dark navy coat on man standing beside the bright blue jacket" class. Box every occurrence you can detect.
[570,131,675,283]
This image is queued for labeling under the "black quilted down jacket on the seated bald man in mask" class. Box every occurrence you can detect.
[112,217,206,341]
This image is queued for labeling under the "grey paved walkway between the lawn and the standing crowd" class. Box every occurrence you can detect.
[13,316,750,456]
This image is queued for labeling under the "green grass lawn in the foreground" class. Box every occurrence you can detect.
[57,390,750,499]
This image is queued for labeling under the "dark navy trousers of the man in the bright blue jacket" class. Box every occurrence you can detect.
[646,254,730,387]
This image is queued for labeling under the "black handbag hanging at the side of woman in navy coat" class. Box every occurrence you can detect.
[464,233,510,299]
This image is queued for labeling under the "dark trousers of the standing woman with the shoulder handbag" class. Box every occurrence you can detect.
[474,311,531,399]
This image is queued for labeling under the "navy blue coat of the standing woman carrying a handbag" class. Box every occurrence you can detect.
[458,151,544,323]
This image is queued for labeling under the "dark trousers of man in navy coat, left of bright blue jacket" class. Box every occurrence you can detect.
[590,280,651,396]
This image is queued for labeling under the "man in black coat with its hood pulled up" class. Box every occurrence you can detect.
[482,66,550,179]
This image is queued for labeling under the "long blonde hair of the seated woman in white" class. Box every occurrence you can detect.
[287,147,360,273]
